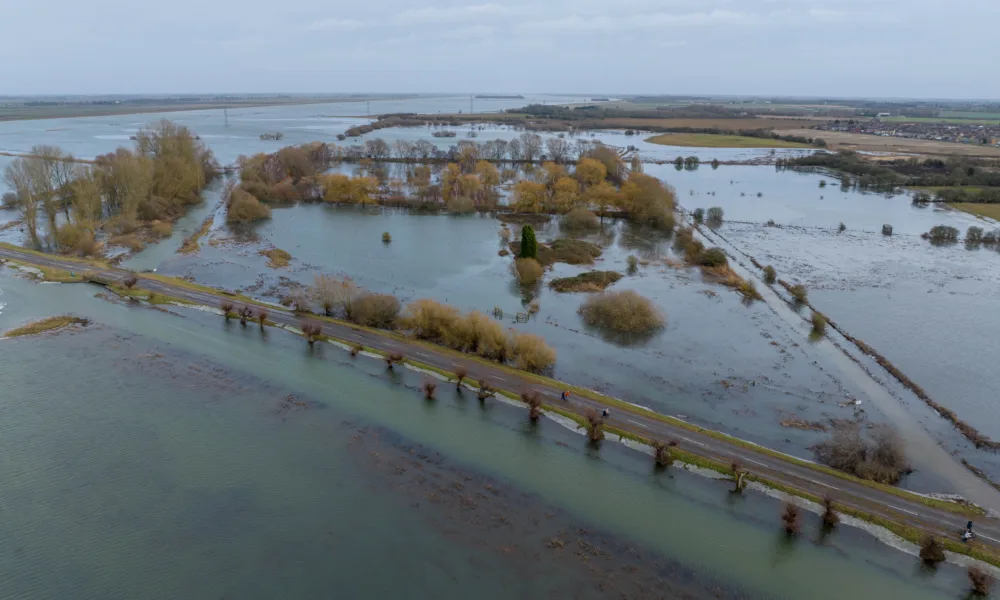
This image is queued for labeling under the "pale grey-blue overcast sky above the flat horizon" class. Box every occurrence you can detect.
[0,0,1000,98]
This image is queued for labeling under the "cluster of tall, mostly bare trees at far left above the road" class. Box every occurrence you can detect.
[4,121,219,250]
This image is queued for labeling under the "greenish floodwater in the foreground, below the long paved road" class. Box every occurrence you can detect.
[0,269,966,599]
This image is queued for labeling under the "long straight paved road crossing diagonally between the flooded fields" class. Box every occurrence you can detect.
[0,245,1000,553]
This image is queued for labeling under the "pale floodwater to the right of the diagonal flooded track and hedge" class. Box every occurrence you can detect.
[647,166,1000,477]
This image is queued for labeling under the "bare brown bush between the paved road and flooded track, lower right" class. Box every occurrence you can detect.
[813,423,910,483]
